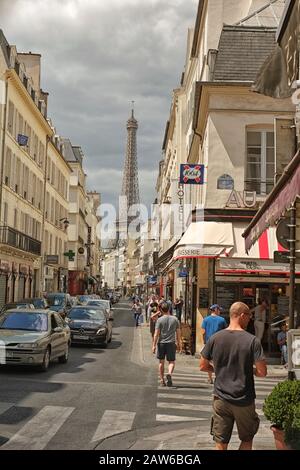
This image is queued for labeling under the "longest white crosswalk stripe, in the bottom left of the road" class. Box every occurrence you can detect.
[1,406,75,450]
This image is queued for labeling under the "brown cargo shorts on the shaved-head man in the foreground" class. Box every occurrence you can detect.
[211,396,259,444]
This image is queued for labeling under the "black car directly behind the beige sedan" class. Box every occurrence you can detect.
[68,305,113,348]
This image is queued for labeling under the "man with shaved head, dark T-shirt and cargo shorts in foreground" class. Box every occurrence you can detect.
[200,302,267,450]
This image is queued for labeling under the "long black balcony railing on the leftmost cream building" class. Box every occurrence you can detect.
[0,225,41,256]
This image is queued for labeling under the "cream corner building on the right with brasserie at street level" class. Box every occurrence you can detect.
[156,0,295,350]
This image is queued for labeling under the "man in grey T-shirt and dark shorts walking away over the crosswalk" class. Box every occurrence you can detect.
[152,302,181,387]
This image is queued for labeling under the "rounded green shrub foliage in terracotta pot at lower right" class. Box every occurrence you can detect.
[263,380,300,431]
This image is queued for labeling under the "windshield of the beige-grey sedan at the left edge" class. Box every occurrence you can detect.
[0,312,48,331]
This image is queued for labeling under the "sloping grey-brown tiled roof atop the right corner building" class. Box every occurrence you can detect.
[213,26,276,82]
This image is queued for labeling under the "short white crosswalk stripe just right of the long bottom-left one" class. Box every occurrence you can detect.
[92,410,136,442]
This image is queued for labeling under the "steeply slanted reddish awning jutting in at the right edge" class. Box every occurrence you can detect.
[243,151,300,251]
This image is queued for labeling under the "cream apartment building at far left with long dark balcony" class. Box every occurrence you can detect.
[0,31,52,304]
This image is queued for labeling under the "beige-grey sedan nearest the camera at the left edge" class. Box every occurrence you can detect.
[0,309,71,371]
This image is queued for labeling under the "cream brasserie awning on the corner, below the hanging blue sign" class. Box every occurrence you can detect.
[173,221,234,260]
